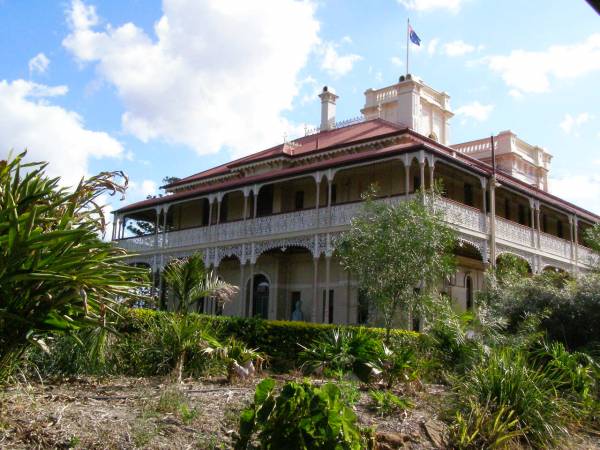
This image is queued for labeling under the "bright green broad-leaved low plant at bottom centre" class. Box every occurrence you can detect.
[236,378,368,450]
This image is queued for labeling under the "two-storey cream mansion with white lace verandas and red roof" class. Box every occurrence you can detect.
[113,76,600,323]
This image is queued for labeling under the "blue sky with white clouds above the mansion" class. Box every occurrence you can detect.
[0,0,600,234]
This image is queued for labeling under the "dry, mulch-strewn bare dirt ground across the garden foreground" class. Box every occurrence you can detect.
[0,377,600,450]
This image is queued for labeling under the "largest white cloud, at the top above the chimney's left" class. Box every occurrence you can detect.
[63,0,319,158]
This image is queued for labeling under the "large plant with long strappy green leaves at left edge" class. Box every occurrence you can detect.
[0,152,146,380]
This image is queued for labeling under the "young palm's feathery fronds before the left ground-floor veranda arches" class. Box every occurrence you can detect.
[164,253,238,314]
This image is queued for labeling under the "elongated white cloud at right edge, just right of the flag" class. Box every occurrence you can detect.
[482,33,600,93]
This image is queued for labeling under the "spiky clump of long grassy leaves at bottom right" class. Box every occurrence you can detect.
[455,348,569,448]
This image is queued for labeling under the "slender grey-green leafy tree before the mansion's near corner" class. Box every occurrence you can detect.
[336,190,456,341]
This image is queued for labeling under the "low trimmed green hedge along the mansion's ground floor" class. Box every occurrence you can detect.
[120,309,424,371]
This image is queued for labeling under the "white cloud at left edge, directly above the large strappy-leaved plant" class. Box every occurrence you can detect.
[0,80,123,185]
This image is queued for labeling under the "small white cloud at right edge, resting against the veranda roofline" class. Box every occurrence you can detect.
[548,174,600,214]
